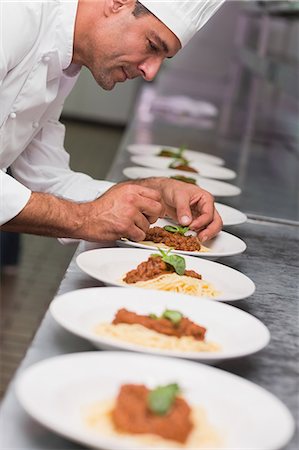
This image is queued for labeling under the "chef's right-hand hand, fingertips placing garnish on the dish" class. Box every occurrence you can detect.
[134,178,223,242]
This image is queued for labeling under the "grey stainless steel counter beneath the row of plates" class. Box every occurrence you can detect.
[0,63,299,450]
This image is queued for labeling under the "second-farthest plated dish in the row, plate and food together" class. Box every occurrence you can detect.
[131,155,236,180]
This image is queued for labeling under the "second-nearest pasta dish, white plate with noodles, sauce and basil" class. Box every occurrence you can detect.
[50,287,270,363]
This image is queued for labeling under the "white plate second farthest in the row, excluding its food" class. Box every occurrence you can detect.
[131,155,236,180]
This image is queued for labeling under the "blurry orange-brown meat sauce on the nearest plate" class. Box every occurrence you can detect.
[111,384,193,443]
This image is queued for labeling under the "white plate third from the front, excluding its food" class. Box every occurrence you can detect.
[76,248,255,301]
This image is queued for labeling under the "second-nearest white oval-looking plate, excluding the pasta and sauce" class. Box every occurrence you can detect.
[50,287,270,363]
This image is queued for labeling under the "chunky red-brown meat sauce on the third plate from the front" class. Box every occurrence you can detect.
[124,256,201,284]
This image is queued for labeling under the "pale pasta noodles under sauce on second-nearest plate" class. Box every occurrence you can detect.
[94,323,220,352]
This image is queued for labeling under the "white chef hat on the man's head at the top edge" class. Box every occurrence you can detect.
[139,0,224,47]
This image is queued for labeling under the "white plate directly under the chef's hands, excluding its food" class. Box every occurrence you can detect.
[116,219,246,259]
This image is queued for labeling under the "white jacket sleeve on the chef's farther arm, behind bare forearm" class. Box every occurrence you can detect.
[11,110,113,202]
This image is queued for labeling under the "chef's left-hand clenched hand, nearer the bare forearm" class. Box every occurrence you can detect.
[80,183,165,241]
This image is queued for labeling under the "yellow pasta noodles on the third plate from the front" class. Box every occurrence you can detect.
[122,273,219,298]
